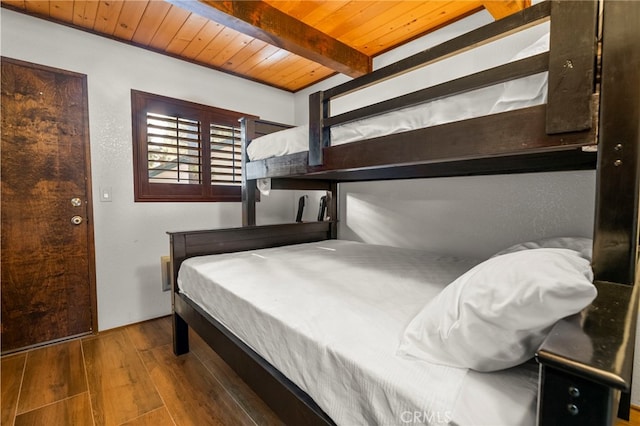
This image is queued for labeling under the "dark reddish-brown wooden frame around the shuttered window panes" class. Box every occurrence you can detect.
[131,90,253,202]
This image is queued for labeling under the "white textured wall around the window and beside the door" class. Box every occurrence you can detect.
[0,9,294,330]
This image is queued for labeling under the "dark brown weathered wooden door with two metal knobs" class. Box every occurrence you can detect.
[1,58,96,353]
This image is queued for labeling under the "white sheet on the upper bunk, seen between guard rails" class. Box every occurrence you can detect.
[247,34,549,161]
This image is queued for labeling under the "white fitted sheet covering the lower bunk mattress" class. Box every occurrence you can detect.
[178,240,538,425]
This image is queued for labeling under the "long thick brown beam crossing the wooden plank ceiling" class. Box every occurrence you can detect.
[168,0,372,77]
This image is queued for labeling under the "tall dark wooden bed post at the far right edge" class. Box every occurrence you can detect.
[593,1,640,285]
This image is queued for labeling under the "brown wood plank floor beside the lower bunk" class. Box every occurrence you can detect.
[0,317,282,426]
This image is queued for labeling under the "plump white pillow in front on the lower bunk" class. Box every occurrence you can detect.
[397,249,597,371]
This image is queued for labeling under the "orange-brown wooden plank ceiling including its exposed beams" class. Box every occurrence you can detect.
[0,0,531,92]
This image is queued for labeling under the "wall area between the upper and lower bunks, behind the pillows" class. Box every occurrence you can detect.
[339,171,595,258]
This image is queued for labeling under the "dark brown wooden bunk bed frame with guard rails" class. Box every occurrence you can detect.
[170,0,640,425]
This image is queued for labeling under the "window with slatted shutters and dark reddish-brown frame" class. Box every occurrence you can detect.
[131,90,247,201]
